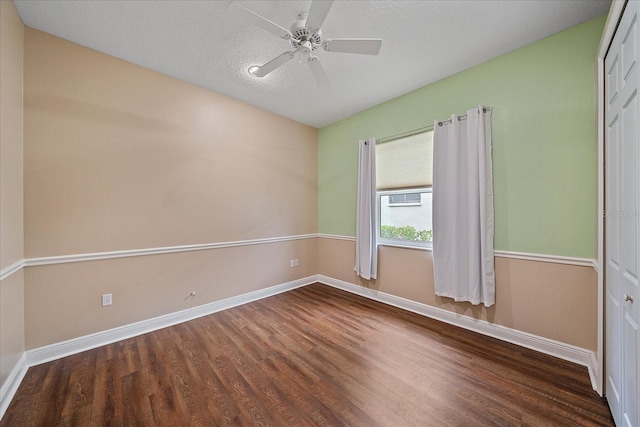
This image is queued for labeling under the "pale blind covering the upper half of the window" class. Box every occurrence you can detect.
[376,131,433,190]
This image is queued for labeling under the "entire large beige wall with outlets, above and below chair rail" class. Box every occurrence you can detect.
[24,28,318,349]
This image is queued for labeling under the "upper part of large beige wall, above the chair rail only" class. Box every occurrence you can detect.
[25,28,318,258]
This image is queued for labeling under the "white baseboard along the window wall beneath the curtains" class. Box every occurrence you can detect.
[318,275,598,391]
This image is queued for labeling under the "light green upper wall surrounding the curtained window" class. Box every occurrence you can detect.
[318,16,605,258]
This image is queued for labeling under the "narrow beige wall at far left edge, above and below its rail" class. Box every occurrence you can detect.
[0,1,25,387]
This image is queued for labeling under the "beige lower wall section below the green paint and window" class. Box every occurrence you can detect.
[318,238,597,351]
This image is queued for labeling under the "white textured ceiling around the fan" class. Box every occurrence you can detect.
[15,0,611,128]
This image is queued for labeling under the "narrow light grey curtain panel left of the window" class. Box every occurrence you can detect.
[355,138,378,280]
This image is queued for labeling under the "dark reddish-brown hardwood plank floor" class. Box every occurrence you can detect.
[0,284,613,427]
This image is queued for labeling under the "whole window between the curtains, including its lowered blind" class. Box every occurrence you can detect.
[376,131,433,247]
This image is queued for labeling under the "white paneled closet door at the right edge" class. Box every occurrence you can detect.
[605,1,640,427]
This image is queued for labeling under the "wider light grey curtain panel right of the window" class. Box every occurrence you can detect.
[433,106,495,307]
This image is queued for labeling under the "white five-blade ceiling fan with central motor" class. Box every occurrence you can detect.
[228,0,382,87]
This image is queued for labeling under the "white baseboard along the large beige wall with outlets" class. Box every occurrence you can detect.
[27,276,316,367]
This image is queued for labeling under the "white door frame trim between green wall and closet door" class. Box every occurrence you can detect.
[595,0,627,396]
